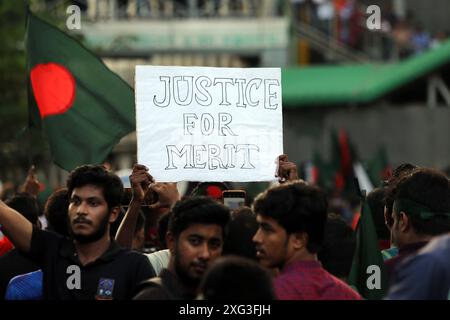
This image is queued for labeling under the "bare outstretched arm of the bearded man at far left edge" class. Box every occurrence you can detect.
[0,200,33,252]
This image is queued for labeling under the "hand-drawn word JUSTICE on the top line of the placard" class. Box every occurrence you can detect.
[153,76,280,110]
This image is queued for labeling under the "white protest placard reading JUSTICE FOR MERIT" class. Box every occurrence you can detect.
[135,66,283,182]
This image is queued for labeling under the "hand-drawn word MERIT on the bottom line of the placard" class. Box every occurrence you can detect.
[165,144,259,170]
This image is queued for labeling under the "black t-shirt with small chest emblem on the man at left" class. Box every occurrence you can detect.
[28,228,155,300]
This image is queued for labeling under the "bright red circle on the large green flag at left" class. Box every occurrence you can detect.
[30,62,75,118]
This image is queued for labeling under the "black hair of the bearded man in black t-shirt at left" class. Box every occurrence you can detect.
[67,164,123,210]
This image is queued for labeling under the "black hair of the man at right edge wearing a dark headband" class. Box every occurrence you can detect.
[389,168,450,236]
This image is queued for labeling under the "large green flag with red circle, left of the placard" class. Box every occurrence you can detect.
[26,12,135,170]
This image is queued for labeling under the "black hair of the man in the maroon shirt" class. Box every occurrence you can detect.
[253,182,328,253]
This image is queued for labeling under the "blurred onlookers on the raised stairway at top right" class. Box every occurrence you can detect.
[291,0,449,60]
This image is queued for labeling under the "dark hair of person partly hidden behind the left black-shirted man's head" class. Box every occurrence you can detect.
[44,188,69,237]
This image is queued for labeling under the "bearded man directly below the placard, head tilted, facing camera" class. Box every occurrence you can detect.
[134,197,230,300]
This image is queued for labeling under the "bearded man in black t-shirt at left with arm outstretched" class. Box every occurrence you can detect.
[0,165,154,300]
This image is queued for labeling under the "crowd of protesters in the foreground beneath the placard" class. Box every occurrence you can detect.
[0,155,450,300]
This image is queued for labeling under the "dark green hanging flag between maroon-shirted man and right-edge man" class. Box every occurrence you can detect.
[348,195,388,300]
